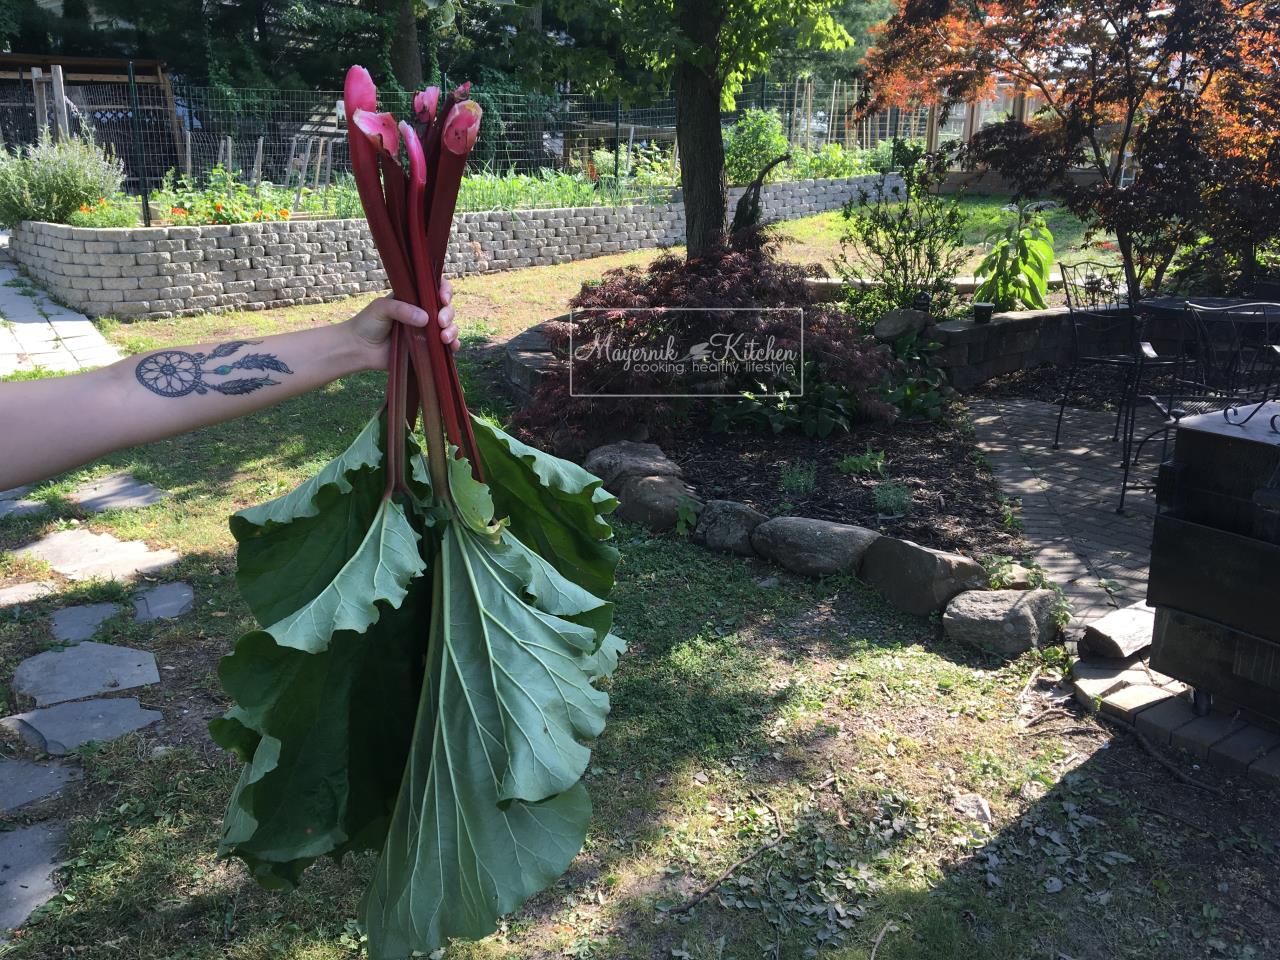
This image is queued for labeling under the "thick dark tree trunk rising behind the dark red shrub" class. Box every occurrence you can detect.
[675,0,726,259]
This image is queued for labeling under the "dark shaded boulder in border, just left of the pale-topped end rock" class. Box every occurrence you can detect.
[861,536,987,617]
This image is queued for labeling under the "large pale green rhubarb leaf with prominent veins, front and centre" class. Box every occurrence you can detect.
[364,461,621,960]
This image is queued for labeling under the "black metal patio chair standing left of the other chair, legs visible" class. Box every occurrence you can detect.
[1053,261,1171,449]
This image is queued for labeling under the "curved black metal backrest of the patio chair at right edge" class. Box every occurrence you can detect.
[1187,301,1280,399]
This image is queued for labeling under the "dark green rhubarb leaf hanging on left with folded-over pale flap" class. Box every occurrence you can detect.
[210,421,429,886]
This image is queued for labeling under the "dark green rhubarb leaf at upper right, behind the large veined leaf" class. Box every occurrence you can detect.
[471,417,618,596]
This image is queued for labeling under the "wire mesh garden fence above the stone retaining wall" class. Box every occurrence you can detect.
[0,68,1000,215]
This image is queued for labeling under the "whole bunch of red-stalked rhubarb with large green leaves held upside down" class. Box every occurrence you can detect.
[210,67,623,960]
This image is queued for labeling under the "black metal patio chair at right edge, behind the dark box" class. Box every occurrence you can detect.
[1116,302,1280,512]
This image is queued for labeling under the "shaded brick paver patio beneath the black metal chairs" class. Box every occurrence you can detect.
[970,399,1156,631]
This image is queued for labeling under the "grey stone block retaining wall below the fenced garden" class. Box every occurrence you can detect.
[9,177,896,317]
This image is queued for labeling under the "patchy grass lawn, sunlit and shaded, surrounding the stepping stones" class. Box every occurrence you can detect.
[0,216,1280,960]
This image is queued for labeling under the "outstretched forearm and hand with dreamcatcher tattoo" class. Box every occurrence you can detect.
[0,289,458,490]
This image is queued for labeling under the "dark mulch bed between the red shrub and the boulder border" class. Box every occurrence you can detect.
[660,411,1023,557]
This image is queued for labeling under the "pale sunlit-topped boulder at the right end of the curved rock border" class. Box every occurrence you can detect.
[942,590,1057,657]
